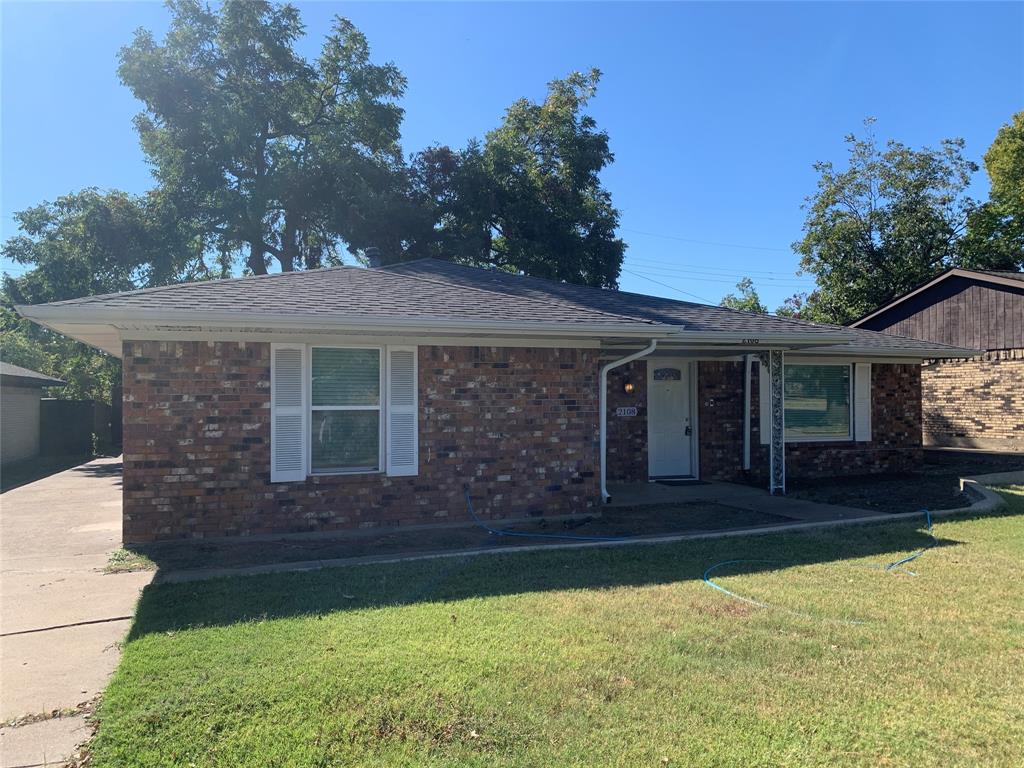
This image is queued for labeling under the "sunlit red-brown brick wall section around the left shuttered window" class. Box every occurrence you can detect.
[124,341,600,543]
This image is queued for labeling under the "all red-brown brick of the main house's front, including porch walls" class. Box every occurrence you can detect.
[124,341,922,543]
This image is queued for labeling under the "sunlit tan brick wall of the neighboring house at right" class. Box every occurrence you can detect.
[921,349,1024,451]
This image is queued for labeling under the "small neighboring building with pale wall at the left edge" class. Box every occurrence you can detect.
[0,362,65,464]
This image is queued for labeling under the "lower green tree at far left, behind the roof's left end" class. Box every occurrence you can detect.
[0,188,214,400]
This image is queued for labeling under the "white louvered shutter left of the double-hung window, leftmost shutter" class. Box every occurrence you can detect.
[270,344,307,482]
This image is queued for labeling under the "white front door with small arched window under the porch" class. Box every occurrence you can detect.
[647,358,693,477]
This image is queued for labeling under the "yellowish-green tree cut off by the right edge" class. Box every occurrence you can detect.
[961,112,1024,270]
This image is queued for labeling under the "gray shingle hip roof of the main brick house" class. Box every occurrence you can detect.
[18,259,974,354]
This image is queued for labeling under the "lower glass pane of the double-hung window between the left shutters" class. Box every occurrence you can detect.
[311,411,381,472]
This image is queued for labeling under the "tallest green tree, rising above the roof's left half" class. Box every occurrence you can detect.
[118,0,406,274]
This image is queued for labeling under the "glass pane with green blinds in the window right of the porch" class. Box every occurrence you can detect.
[785,366,850,437]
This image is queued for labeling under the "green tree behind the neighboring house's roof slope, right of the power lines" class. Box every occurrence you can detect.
[794,120,977,324]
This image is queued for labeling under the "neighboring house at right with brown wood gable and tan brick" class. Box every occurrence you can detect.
[852,269,1024,451]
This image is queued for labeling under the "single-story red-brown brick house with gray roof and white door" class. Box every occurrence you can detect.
[18,259,970,543]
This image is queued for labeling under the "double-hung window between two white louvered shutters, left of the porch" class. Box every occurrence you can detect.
[309,347,381,474]
